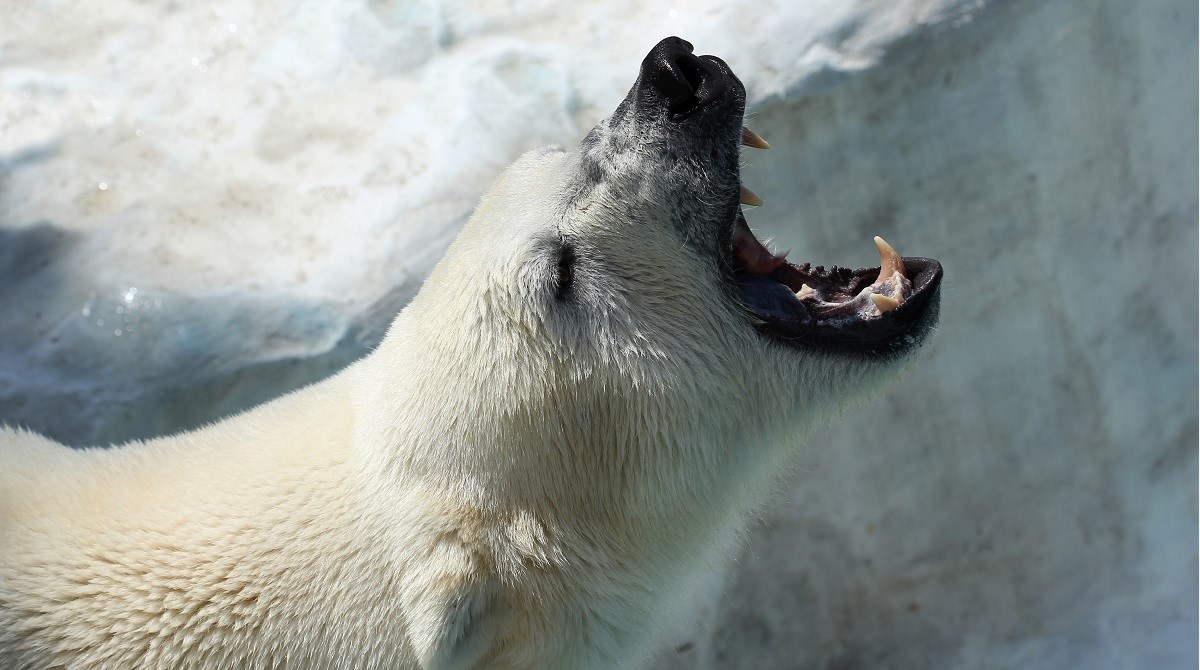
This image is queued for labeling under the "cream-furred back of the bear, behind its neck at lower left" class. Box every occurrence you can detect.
[0,375,427,668]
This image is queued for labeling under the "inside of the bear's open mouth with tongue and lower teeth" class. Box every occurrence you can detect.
[732,211,914,327]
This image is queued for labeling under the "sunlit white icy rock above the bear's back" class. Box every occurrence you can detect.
[0,1,972,444]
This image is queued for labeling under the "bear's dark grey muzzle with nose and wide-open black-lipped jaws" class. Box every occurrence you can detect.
[575,37,942,355]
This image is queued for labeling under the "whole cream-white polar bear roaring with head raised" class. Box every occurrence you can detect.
[0,37,941,669]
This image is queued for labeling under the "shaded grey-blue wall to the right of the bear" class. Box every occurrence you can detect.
[660,1,1198,670]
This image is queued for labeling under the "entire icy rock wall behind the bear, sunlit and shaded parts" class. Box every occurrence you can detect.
[0,0,1198,669]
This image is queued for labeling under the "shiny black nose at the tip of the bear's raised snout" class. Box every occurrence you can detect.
[638,37,734,120]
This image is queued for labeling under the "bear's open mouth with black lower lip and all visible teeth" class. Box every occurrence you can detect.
[731,128,942,353]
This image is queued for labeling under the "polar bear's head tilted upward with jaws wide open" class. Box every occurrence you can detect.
[360,37,941,514]
